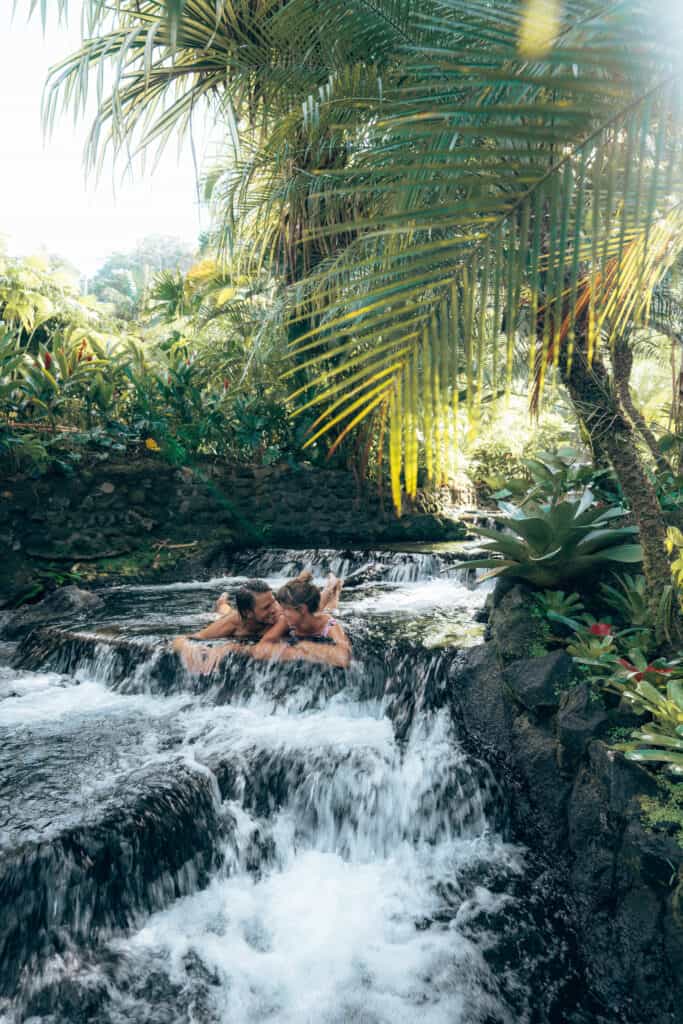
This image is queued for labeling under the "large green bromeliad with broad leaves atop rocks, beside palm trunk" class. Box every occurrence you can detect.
[467,489,642,589]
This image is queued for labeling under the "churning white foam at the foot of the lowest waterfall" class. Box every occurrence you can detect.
[120,841,512,1024]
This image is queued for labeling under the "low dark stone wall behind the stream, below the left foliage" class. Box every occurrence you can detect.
[0,454,462,607]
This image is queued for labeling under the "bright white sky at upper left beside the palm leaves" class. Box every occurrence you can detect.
[0,0,208,276]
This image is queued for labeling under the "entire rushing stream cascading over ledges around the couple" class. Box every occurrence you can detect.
[0,552,588,1024]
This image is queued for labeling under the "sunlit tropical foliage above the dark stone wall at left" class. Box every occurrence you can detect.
[0,251,315,467]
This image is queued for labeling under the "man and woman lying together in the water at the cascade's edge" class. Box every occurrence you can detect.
[173,571,351,673]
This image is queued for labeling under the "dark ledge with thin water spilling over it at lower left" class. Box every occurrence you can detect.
[0,762,222,995]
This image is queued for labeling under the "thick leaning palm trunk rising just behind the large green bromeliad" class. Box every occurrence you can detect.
[562,345,680,629]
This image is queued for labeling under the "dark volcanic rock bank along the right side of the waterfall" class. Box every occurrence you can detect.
[451,587,683,1024]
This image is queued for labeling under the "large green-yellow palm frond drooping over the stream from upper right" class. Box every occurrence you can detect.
[264,0,683,503]
